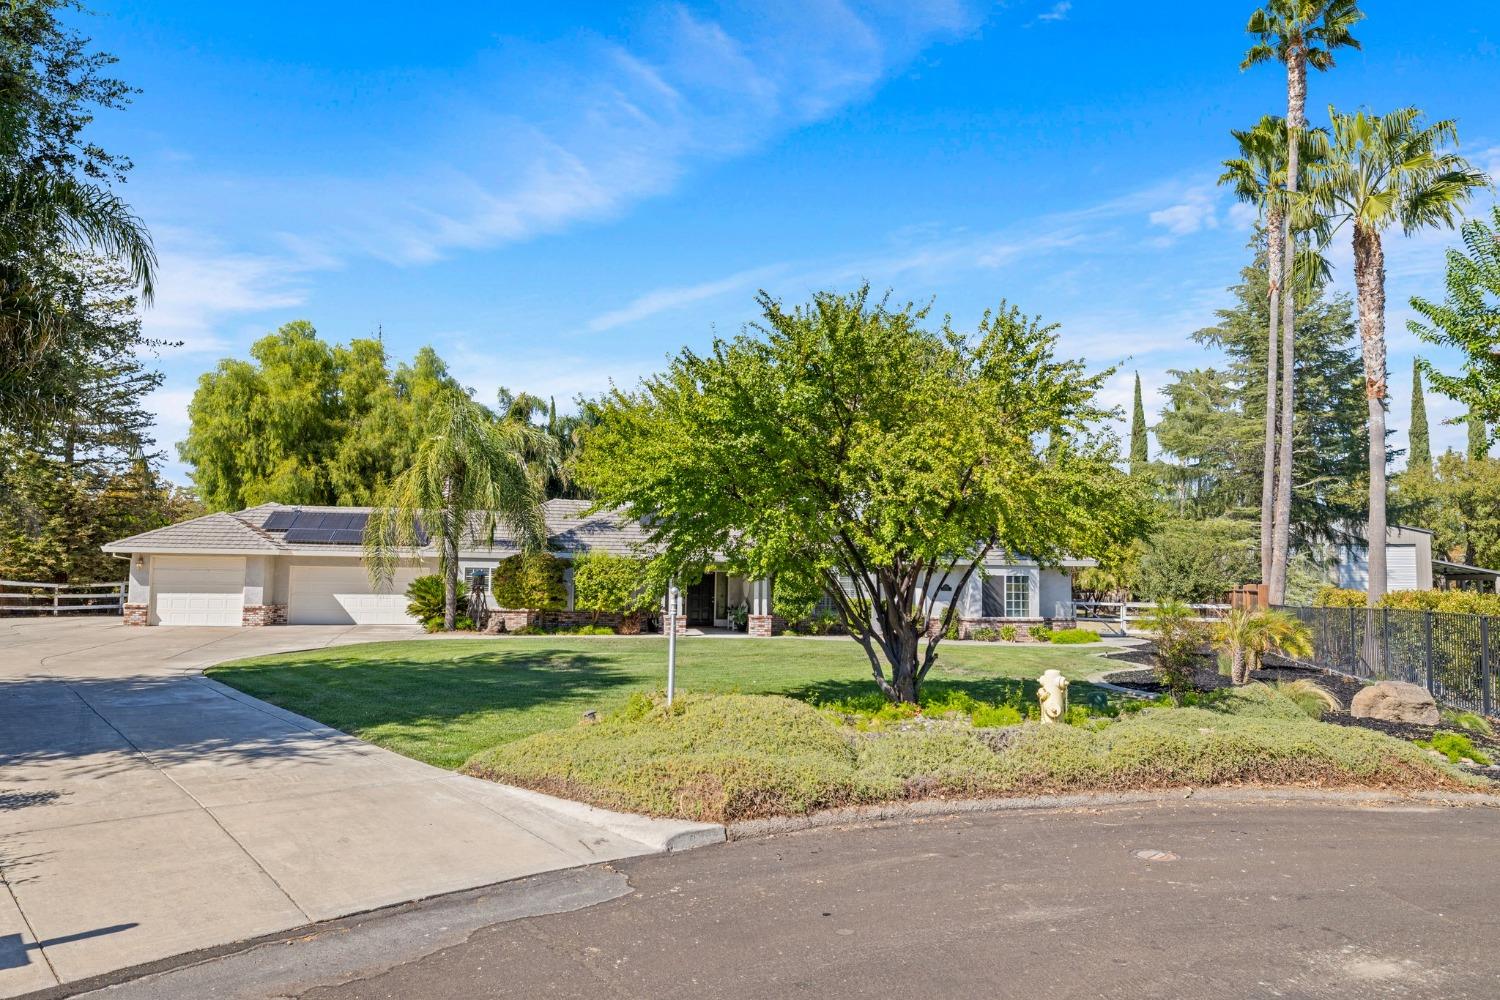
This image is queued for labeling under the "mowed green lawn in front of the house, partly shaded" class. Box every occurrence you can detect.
[209,637,1110,768]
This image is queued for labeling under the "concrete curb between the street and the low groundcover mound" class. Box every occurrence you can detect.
[726,789,1500,841]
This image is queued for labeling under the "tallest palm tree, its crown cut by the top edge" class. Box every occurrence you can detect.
[1241,0,1365,603]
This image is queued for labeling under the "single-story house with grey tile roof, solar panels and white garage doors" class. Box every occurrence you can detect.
[104,499,1092,636]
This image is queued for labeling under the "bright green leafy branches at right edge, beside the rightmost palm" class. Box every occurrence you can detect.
[1407,205,1500,437]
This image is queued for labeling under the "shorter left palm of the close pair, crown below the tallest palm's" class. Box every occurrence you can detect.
[1218,114,1328,583]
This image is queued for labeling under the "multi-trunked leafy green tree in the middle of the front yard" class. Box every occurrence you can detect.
[579,288,1148,702]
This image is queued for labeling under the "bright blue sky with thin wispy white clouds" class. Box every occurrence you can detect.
[83,0,1500,478]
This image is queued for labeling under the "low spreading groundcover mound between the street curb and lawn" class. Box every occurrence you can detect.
[464,687,1479,822]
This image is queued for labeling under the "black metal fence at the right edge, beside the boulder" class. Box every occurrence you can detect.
[1281,607,1500,715]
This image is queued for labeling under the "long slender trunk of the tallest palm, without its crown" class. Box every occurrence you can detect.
[1269,45,1308,604]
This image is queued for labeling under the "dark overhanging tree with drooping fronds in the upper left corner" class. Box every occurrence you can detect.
[0,0,156,426]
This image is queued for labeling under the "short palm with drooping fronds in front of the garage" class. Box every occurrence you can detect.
[365,391,549,631]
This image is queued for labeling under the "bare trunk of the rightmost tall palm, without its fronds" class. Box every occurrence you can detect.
[1355,222,1386,607]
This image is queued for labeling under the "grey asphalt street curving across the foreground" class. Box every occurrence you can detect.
[64,801,1500,1000]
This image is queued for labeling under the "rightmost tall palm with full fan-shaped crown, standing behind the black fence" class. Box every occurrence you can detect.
[1311,108,1488,607]
